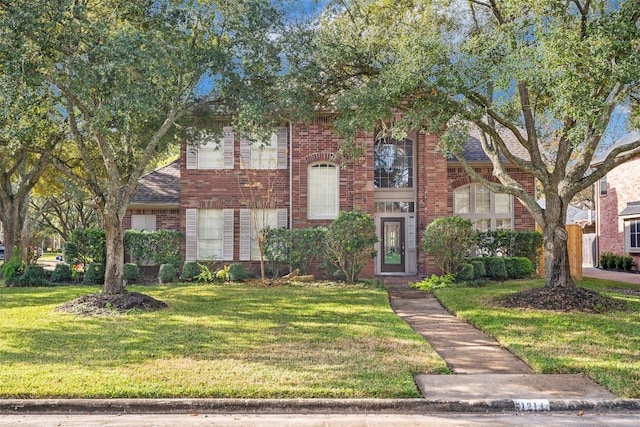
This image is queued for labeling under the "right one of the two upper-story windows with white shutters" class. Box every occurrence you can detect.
[240,127,287,169]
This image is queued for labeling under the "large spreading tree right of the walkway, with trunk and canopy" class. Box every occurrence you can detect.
[301,0,640,300]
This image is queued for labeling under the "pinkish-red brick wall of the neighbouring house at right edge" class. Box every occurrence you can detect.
[595,157,640,265]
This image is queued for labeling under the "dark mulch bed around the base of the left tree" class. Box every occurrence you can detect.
[57,292,167,316]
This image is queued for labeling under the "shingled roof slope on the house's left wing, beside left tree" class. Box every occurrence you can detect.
[129,159,180,208]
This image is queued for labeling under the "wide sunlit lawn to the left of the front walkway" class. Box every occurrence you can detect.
[0,284,447,398]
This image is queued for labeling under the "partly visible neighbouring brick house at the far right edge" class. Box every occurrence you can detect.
[593,132,640,266]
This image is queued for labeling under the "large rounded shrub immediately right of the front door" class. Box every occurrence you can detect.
[422,216,476,274]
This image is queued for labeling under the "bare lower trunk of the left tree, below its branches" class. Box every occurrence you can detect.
[102,207,126,295]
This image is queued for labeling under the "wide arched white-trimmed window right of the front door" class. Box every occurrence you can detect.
[453,183,513,231]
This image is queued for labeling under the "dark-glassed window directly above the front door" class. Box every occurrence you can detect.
[373,138,413,188]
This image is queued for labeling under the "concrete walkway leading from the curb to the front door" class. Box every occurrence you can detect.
[386,282,615,405]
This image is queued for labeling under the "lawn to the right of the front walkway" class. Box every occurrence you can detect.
[435,279,640,398]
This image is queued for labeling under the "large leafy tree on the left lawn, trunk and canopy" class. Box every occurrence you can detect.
[0,0,290,294]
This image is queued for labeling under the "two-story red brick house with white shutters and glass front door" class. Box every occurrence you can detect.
[126,117,535,277]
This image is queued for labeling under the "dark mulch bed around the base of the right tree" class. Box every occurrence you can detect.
[498,286,626,313]
